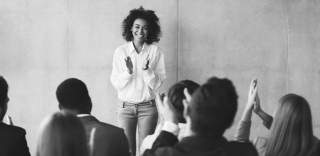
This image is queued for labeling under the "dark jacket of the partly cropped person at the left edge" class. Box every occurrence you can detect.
[0,122,30,156]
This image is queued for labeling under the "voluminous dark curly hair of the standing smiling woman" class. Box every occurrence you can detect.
[122,6,162,44]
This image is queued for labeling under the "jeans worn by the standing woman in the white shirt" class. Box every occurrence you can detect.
[117,100,158,156]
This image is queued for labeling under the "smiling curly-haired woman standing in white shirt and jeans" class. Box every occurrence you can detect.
[110,7,166,155]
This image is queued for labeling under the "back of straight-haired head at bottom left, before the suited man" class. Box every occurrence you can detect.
[36,112,89,156]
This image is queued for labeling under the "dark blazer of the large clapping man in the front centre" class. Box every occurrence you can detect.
[143,131,258,156]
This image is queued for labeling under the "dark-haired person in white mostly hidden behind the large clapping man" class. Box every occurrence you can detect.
[140,80,200,153]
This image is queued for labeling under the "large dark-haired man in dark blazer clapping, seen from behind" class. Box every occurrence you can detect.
[143,78,257,156]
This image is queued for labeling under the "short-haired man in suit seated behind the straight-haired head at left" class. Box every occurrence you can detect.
[56,78,130,156]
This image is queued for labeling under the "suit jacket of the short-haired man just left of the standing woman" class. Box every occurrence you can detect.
[79,116,130,156]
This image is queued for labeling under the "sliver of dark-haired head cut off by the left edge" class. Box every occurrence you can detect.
[0,75,9,121]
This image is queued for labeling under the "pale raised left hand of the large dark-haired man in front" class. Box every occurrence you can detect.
[156,93,178,124]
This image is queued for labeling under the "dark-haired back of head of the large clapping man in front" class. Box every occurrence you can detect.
[187,77,238,136]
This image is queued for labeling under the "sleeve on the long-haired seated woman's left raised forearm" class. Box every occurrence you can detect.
[234,120,251,142]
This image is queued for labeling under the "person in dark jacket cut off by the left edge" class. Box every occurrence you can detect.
[0,76,30,156]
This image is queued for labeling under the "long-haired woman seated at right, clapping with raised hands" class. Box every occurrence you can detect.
[235,79,317,156]
